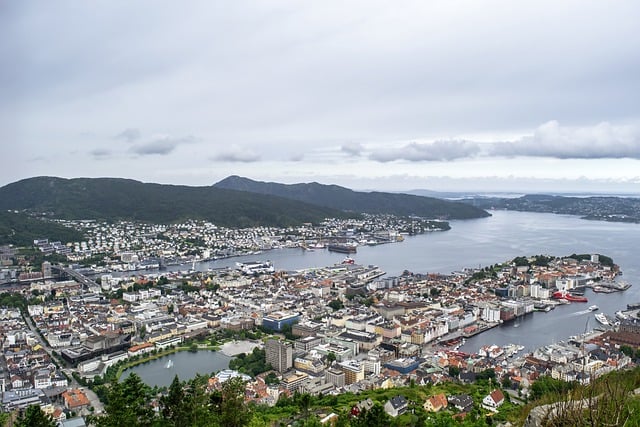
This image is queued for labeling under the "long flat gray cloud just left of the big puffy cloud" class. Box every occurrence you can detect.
[369,140,480,162]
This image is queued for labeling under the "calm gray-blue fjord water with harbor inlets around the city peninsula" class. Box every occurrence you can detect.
[214,211,640,352]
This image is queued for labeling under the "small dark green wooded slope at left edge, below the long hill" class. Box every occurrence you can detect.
[0,211,83,246]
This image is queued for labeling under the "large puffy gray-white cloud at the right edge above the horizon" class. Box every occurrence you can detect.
[490,120,640,159]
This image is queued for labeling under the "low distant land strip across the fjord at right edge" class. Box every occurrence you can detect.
[465,195,640,223]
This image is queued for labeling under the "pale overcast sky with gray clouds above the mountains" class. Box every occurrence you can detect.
[0,0,640,193]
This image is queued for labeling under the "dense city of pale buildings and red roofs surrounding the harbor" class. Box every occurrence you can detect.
[0,216,640,423]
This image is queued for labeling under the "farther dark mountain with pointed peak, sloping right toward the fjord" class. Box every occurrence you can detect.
[214,176,489,219]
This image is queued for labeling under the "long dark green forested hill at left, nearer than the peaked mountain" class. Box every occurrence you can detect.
[0,177,353,227]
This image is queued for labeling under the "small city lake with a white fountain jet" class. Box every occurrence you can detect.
[122,350,231,387]
